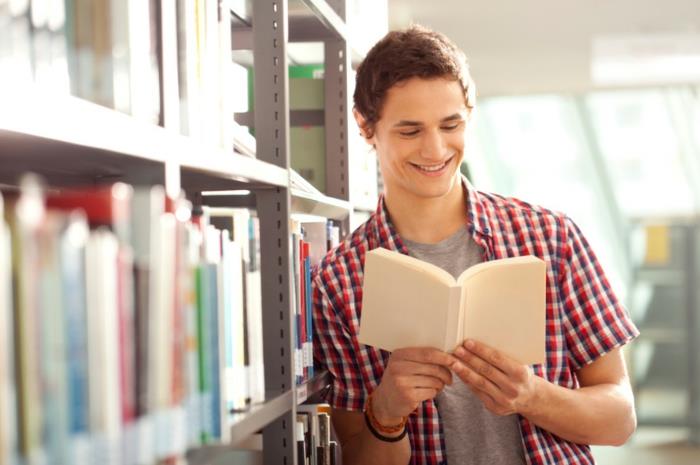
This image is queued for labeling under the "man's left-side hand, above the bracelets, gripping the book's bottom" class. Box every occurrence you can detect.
[372,348,456,425]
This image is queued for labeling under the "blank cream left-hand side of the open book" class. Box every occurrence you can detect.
[359,249,459,351]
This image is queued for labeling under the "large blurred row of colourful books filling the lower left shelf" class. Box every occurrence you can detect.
[0,177,265,465]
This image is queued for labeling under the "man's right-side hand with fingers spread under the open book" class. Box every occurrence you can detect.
[452,339,538,415]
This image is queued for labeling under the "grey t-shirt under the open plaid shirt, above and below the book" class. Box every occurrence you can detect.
[403,227,525,465]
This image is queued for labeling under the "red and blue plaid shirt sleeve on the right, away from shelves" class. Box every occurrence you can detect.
[559,217,639,370]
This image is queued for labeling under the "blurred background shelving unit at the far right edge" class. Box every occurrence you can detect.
[631,217,700,444]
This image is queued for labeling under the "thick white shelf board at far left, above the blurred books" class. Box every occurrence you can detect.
[0,86,171,184]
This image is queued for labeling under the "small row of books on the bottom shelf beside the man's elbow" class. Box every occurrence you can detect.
[295,404,340,465]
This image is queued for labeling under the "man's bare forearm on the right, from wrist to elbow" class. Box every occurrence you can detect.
[519,377,637,445]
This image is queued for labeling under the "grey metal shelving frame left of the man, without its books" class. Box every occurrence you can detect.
[0,0,372,465]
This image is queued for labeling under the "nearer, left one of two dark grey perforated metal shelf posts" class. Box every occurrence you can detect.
[253,0,296,465]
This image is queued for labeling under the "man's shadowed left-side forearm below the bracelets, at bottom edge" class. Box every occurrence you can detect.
[343,425,411,465]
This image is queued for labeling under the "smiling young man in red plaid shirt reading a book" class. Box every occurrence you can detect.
[313,27,638,465]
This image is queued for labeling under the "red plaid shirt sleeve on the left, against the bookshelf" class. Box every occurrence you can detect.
[312,273,366,411]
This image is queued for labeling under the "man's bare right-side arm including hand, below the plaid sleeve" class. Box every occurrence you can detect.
[453,341,637,446]
